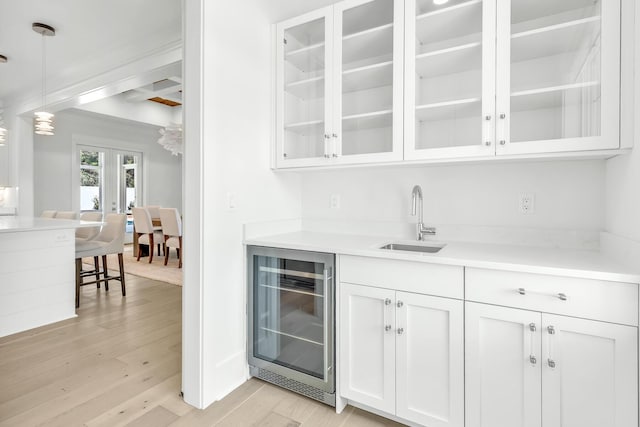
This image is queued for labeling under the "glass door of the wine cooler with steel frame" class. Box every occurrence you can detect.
[251,254,334,391]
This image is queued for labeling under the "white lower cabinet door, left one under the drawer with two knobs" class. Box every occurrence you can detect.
[465,302,546,427]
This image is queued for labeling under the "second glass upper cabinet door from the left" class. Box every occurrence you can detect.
[331,0,404,163]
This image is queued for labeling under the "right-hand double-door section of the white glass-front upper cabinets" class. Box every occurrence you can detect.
[404,0,620,159]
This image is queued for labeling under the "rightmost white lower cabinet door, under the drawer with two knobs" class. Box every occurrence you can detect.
[542,314,638,427]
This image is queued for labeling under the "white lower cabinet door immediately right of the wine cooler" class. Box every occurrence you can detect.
[339,283,396,414]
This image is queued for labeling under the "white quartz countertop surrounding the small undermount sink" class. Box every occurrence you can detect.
[245,231,640,283]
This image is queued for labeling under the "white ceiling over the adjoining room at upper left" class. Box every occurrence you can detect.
[0,0,182,103]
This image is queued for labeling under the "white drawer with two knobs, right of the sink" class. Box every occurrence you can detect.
[465,268,638,326]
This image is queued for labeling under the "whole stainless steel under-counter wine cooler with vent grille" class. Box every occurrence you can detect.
[247,246,335,406]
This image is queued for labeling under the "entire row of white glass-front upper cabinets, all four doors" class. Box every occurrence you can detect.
[275,0,632,168]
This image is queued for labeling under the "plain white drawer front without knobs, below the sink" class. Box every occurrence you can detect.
[340,255,464,299]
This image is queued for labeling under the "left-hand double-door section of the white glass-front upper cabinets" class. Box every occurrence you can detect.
[275,0,404,168]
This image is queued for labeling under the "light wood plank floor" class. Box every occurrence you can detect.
[0,275,400,427]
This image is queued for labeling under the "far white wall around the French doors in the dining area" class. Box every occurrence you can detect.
[34,110,182,215]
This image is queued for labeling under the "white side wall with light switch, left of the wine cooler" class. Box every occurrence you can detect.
[183,0,342,407]
